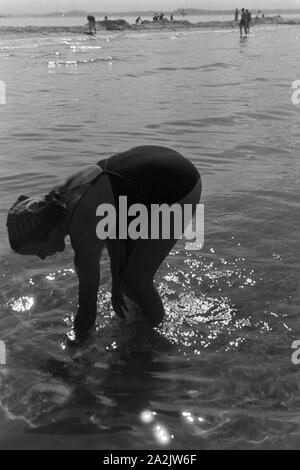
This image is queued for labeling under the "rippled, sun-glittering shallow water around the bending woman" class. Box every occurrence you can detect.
[0,23,300,449]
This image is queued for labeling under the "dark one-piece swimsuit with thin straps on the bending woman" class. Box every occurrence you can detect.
[60,146,200,233]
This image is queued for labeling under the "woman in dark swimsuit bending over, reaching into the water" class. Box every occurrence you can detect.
[7,146,202,341]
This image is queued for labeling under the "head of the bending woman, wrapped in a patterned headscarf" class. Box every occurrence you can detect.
[6,193,67,259]
